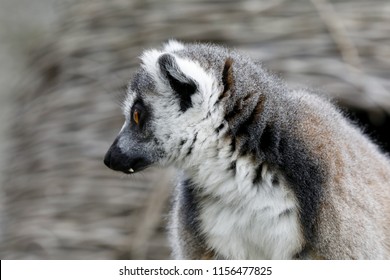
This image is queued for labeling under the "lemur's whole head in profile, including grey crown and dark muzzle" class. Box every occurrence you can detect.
[104,41,268,173]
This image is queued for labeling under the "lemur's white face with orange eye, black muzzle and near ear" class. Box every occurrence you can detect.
[104,42,222,173]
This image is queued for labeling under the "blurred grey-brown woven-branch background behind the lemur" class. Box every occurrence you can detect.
[0,0,390,259]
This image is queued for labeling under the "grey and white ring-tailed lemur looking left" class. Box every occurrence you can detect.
[104,41,390,259]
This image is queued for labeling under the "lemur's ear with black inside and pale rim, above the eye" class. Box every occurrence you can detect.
[158,54,197,112]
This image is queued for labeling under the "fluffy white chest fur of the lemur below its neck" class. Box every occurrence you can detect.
[187,132,303,259]
